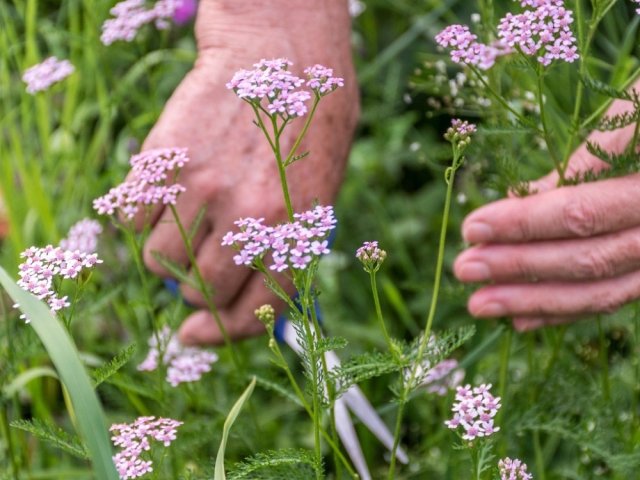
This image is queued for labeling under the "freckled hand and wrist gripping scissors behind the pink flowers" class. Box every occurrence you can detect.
[138,0,359,344]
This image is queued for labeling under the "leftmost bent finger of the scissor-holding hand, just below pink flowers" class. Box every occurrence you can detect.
[143,188,211,276]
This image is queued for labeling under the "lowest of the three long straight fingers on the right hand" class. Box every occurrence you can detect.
[467,271,640,318]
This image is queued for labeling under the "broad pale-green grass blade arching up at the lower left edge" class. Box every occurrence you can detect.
[0,267,118,480]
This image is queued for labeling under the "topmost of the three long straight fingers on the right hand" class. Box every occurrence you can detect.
[462,174,640,243]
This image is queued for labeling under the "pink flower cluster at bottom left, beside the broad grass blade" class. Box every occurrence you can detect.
[109,417,182,480]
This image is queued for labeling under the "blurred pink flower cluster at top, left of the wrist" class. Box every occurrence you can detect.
[100,0,183,45]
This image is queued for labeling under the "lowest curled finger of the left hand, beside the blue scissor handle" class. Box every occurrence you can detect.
[179,272,284,345]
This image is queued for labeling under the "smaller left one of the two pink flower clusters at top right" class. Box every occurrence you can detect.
[436,25,512,70]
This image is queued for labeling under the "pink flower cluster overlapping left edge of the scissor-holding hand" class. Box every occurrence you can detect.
[93,148,189,219]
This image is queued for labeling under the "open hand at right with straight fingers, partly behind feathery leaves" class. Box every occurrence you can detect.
[454,83,640,330]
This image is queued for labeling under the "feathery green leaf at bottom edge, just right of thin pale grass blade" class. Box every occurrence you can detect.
[229,449,322,480]
